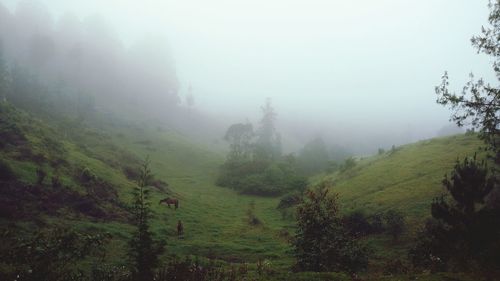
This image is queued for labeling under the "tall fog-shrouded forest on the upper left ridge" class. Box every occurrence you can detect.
[0,2,180,117]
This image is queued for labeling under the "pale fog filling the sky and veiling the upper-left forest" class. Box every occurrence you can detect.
[0,0,496,154]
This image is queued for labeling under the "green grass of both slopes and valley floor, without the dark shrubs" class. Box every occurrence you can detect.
[0,102,488,280]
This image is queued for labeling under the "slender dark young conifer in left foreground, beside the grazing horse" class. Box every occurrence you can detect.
[129,158,164,281]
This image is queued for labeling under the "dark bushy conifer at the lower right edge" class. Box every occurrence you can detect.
[410,157,500,270]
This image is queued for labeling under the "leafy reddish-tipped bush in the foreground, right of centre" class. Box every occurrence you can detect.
[294,182,368,272]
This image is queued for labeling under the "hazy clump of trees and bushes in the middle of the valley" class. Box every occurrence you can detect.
[217,100,307,196]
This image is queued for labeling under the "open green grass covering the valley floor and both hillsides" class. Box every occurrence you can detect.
[0,100,481,280]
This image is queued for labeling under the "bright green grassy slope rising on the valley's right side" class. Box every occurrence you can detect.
[319,135,482,219]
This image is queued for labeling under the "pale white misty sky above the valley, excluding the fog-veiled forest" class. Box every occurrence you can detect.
[0,0,495,149]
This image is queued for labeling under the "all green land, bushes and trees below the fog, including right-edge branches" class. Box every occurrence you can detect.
[0,3,500,281]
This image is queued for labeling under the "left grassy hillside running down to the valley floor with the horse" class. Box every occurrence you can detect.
[0,101,290,264]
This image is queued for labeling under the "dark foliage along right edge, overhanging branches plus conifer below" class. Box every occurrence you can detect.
[424,1,500,272]
